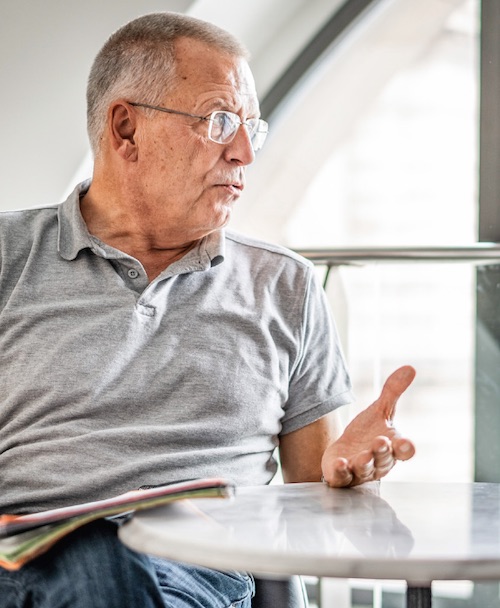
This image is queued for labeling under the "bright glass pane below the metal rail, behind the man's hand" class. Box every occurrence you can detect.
[327,262,476,481]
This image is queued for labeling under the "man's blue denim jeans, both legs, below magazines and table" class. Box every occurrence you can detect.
[0,520,253,608]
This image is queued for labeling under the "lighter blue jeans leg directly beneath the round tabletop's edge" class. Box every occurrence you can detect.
[150,556,254,608]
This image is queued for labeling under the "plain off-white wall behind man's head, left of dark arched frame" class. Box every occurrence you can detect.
[0,0,337,209]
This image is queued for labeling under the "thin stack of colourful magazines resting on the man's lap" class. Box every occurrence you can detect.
[0,479,233,570]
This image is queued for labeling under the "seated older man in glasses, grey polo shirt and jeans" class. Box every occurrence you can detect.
[0,13,414,608]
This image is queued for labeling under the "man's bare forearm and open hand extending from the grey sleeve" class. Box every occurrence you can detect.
[280,366,415,487]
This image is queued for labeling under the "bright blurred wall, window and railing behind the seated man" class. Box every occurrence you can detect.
[0,0,500,608]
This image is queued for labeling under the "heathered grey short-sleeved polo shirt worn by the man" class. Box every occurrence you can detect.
[0,184,352,512]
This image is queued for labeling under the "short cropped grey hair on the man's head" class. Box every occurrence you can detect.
[87,12,248,155]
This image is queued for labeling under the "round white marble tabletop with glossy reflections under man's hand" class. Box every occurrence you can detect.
[119,481,500,587]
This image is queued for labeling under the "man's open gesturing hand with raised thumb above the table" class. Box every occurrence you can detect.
[321,365,415,488]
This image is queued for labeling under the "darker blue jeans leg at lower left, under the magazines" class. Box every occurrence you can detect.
[0,520,164,608]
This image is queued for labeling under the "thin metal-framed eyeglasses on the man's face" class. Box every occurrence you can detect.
[128,101,269,152]
